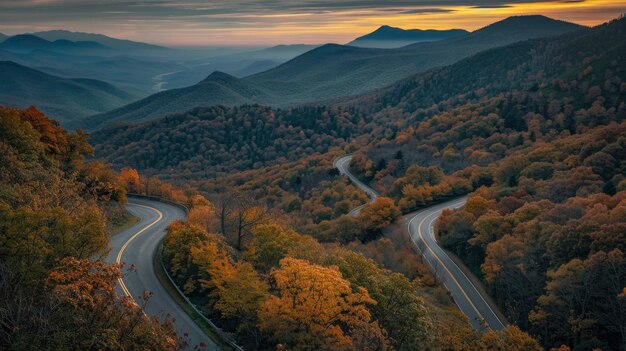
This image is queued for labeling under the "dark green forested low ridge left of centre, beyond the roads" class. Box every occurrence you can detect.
[91,105,358,179]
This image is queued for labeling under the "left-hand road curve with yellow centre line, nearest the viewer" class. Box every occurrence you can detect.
[107,198,219,350]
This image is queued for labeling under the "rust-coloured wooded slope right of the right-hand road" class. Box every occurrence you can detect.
[438,123,626,350]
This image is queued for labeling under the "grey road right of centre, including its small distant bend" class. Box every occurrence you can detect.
[334,156,506,331]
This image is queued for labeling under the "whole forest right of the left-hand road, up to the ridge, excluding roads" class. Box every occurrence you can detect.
[83,13,626,351]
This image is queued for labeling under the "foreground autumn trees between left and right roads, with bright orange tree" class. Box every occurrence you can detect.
[163,193,541,350]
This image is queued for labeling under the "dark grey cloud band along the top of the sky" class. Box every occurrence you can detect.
[0,0,576,23]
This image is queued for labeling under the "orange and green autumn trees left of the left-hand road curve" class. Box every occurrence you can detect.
[0,107,183,350]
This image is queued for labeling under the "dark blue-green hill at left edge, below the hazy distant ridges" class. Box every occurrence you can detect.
[0,61,138,123]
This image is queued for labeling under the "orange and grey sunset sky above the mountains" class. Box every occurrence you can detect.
[0,0,626,46]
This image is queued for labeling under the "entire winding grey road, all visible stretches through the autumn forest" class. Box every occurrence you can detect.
[102,156,505,350]
